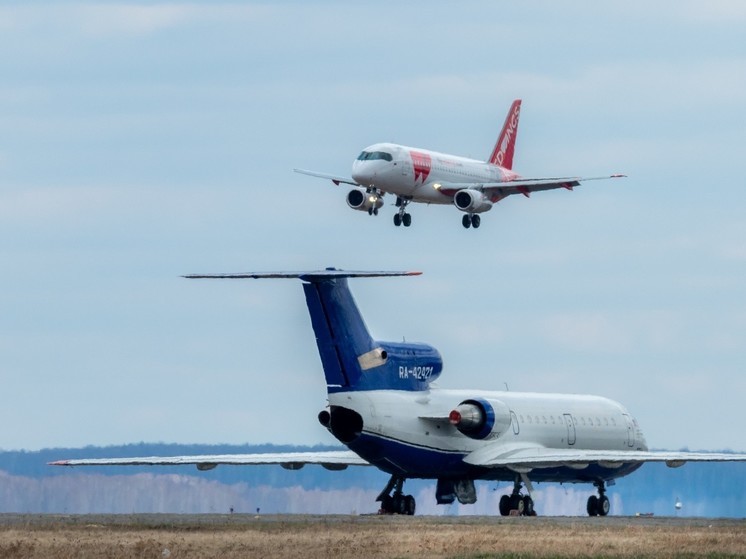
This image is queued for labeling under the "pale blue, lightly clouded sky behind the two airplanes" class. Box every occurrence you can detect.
[0,0,746,451]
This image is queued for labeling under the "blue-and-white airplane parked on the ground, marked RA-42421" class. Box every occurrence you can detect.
[51,268,746,516]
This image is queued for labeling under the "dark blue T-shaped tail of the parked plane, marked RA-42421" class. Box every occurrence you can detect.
[185,268,443,393]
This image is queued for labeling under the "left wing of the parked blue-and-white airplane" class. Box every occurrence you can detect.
[49,450,370,470]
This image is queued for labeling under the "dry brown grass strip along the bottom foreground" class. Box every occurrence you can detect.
[0,515,746,559]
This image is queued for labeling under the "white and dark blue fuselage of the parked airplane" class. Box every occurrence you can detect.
[329,388,647,482]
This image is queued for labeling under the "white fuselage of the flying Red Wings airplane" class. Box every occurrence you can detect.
[352,143,518,204]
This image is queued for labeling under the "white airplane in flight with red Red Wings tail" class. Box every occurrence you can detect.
[294,99,624,229]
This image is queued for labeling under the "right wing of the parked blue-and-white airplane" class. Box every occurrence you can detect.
[464,444,746,472]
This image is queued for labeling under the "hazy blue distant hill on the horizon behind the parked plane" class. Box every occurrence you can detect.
[0,443,746,518]
